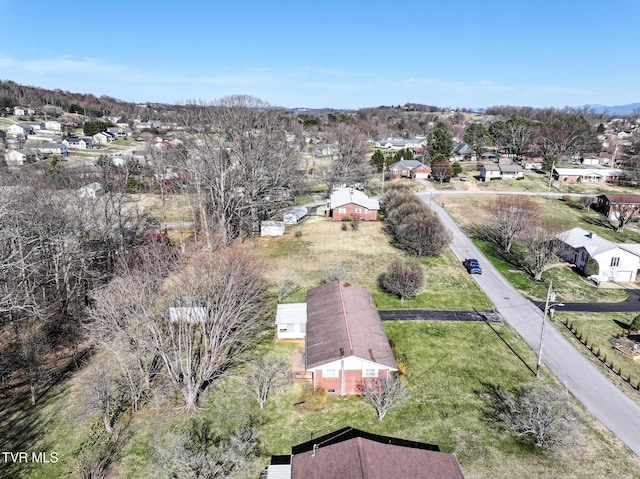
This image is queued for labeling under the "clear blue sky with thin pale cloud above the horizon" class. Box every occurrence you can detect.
[0,0,640,108]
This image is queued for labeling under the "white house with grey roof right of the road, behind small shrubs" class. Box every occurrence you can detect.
[557,227,640,284]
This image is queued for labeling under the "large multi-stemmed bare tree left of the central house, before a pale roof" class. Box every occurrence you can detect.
[146,247,265,410]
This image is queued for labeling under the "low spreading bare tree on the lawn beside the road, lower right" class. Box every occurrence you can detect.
[486,383,583,452]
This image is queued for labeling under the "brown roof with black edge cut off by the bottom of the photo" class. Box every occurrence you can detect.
[267,427,464,479]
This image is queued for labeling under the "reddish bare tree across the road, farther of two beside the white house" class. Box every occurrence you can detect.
[488,196,539,253]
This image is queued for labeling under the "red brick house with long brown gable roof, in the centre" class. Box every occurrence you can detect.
[305,281,398,396]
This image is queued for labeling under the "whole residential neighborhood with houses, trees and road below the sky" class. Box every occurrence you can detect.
[0,81,640,479]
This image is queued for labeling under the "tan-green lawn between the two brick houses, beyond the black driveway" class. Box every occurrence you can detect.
[248,216,491,310]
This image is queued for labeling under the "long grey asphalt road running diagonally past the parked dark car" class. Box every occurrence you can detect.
[418,193,640,455]
